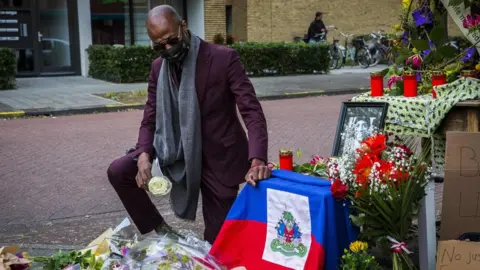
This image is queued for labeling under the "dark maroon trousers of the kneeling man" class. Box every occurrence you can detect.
[107,155,238,243]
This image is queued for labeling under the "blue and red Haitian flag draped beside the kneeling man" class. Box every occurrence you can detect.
[210,170,356,270]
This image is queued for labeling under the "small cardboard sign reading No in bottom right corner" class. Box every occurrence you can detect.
[436,240,480,270]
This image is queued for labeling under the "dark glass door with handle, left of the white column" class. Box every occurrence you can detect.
[35,0,77,73]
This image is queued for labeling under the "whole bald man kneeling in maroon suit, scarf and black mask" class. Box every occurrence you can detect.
[108,5,270,243]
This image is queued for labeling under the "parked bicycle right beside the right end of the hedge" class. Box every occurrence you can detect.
[331,32,372,69]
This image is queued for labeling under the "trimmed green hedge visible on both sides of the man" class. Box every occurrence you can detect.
[87,42,330,83]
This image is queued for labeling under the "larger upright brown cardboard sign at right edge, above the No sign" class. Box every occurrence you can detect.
[440,132,480,239]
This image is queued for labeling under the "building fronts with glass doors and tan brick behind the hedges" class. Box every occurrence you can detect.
[0,0,461,76]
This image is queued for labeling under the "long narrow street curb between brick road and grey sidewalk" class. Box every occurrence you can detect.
[0,89,368,118]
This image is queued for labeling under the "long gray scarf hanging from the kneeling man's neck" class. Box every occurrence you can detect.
[154,34,202,220]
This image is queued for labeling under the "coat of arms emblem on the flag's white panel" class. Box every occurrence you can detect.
[270,211,307,257]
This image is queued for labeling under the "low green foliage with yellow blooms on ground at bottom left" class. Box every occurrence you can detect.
[33,250,103,270]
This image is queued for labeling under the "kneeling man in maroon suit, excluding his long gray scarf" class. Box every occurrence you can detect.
[108,6,270,243]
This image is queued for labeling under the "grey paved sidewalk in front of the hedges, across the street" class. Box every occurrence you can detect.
[0,66,385,112]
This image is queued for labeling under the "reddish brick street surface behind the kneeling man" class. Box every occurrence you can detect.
[0,96,442,248]
